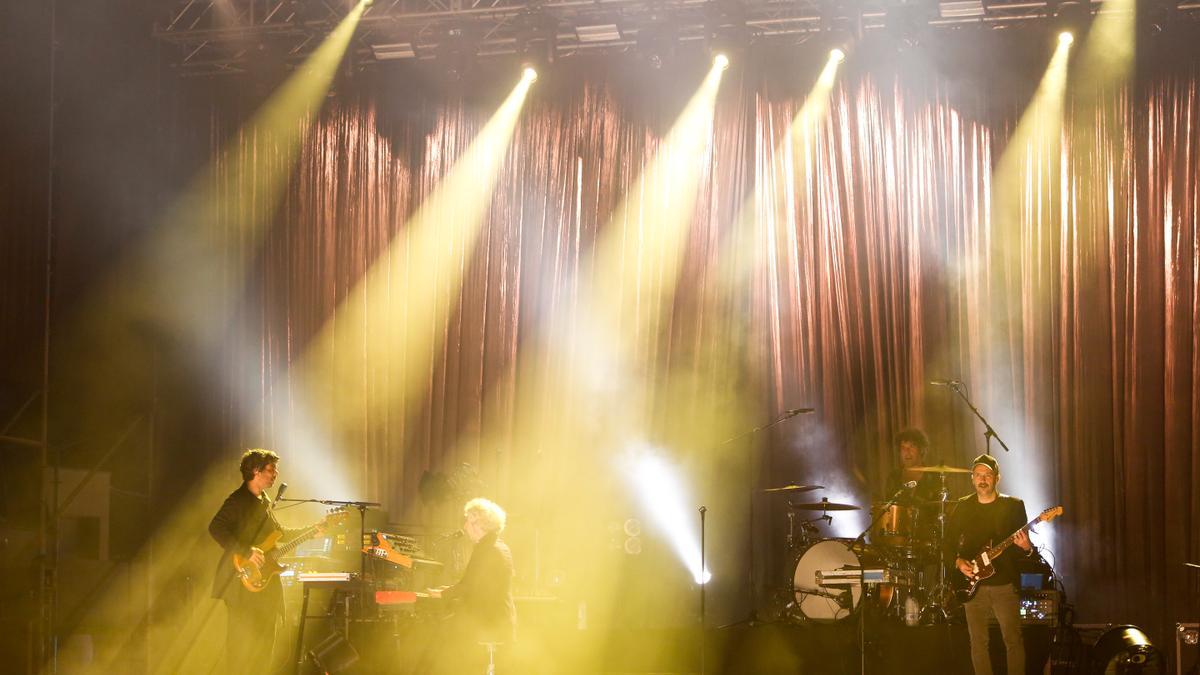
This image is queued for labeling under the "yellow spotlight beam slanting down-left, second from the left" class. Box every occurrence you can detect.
[299,73,534,451]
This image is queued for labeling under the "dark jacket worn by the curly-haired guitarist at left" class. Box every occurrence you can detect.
[209,483,294,600]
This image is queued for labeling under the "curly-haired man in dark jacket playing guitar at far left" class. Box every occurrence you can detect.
[209,448,312,674]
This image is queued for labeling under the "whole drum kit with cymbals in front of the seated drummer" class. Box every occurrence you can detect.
[763,465,970,626]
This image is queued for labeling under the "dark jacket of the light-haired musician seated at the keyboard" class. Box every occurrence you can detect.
[442,533,517,643]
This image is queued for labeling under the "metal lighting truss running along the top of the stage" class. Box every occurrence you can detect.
[154,0,1200,76]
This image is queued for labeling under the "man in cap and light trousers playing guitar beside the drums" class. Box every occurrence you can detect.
[946,454,1033,675]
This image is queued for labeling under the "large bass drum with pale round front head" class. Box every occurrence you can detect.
[792,539,894,623]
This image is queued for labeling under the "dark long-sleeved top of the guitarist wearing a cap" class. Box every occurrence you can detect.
[946,495,1028,586]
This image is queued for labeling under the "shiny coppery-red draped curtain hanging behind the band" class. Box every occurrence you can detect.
[0,60,1200,643]
